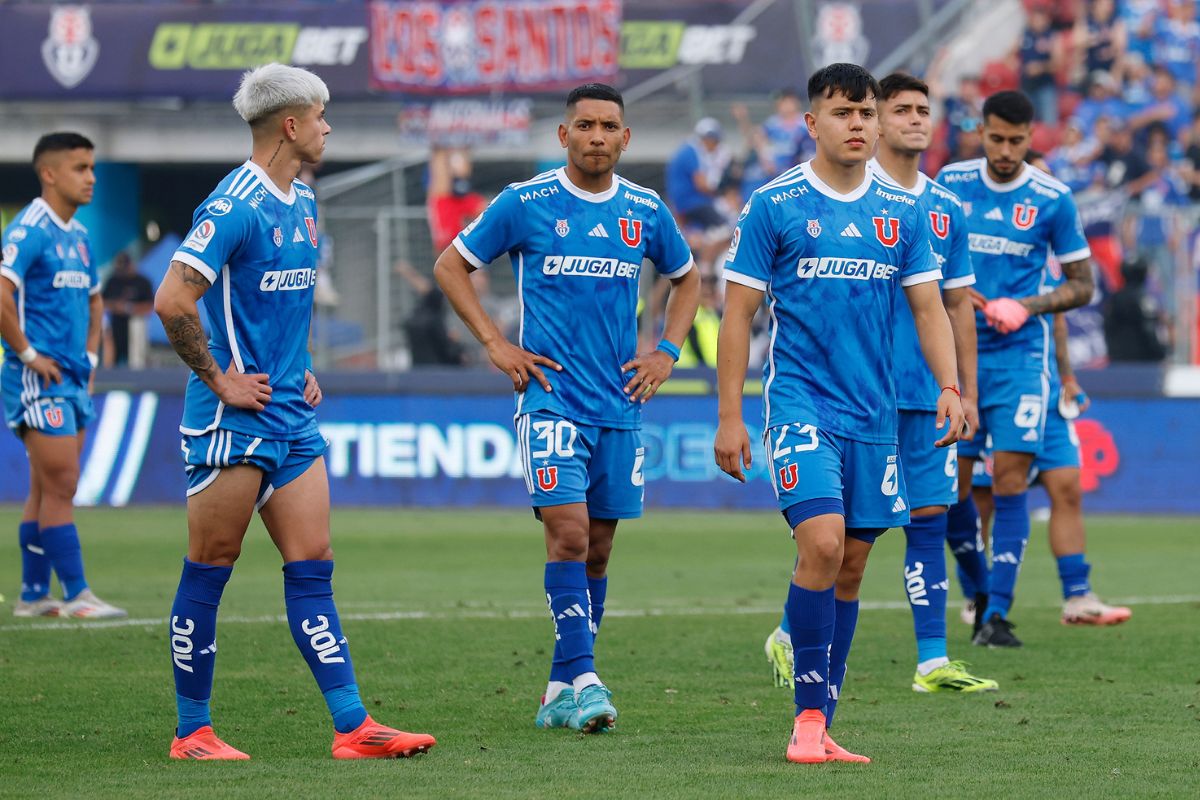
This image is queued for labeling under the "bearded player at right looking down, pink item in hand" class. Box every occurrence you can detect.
[938,91,1092,648]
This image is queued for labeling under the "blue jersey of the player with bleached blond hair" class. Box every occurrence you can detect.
[172,161,319,439]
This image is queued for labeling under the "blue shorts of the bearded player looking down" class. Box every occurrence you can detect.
[979,369,1050,455]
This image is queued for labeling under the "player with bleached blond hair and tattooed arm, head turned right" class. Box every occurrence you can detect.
[155,64,436,760]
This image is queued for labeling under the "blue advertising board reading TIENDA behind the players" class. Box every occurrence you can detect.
[0,391,1200,513]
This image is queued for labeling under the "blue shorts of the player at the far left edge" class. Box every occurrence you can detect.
[0,360,96,437]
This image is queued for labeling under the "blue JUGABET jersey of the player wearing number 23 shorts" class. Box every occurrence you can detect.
[725,162,942,444]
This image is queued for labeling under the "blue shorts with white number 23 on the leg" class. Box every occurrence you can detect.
[764,423,908,530]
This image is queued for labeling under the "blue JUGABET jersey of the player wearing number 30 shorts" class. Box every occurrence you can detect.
[454,168,692,429]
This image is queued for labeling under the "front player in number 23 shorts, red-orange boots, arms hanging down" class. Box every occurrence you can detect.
[714,64,962,763]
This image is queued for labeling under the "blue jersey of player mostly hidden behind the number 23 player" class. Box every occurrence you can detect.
[870,158,974,411]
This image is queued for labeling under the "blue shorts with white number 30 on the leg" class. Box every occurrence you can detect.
[515,411,646,519]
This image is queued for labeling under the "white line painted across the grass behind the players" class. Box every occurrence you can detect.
[0,595,1200,633]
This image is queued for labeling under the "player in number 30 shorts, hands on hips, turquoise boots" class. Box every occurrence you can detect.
[434,84,700,733]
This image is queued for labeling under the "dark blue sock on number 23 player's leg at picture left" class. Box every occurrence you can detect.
[786,583,835,715]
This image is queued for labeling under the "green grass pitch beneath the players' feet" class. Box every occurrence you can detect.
[0,509,1200,800]
